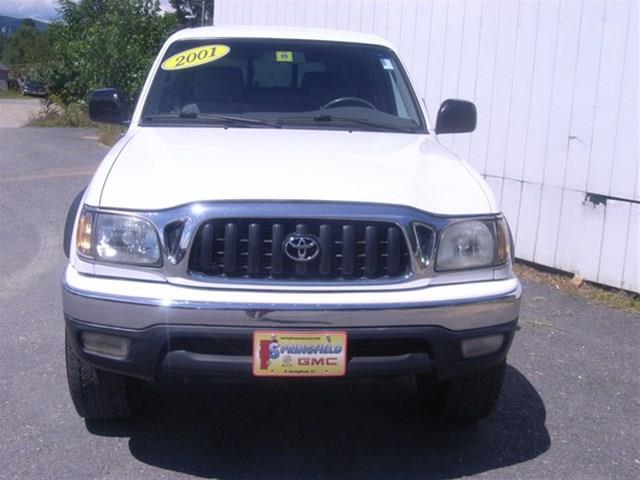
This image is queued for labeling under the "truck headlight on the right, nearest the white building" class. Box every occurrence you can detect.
[436,218,510,270]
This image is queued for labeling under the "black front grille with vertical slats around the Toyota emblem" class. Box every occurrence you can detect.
[189,219,410,281]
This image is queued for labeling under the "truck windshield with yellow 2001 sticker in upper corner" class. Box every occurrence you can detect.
[141,39,426,133]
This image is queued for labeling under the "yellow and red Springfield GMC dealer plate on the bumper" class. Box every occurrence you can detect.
[253,330,347,377]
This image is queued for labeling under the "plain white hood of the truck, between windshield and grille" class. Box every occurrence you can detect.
[100,127,496,215]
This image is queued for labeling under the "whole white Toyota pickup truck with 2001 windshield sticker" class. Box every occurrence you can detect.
[62,27,521,421]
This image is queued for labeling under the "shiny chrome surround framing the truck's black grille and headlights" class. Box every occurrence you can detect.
[79,201,510,291]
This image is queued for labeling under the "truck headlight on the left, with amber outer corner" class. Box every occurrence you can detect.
[76,211,161,266]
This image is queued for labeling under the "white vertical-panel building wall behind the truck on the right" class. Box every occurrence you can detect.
[215,0,640,292]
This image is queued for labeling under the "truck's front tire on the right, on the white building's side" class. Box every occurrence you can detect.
[417,361,507,423]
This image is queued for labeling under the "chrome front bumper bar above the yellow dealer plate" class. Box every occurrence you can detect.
[62,266,522,331]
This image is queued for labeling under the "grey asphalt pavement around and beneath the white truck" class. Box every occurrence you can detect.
[0,128,640,479]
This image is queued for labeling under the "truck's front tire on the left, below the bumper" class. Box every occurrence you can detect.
[65,335,133,420]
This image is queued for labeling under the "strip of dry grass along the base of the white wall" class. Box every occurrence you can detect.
[513,262,640,314]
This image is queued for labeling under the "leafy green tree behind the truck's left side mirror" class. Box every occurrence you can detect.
[48,0,177,103]
